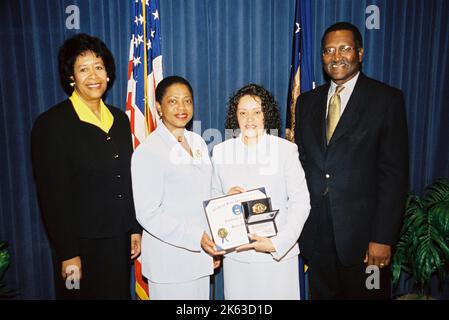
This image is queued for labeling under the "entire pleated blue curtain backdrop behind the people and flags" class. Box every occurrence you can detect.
[0,0,449,299]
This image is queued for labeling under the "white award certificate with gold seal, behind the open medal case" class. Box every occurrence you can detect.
[203,188,266,251]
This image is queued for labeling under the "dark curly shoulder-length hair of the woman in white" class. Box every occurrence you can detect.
[225,83,281,135]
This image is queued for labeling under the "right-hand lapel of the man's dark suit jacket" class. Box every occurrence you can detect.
[329,73,364,146]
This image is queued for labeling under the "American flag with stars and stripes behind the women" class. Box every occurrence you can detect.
[126,0,162,300]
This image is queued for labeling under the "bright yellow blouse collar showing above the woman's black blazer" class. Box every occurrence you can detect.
[70,90,114,133]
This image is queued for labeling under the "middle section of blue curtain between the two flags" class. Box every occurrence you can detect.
[160,0,295,148]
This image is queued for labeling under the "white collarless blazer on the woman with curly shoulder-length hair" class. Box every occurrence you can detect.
[212,133,310,262]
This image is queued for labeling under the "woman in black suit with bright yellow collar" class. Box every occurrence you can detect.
[31,34,141,299]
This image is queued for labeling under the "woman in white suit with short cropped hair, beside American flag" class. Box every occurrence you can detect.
[131,76,218,300]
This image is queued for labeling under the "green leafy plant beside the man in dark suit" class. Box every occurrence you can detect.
[392,178,449,299]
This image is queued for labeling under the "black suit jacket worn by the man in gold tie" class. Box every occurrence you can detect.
[295,73,409,265]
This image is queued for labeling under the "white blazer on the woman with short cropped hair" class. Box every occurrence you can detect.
[131,123,213,283]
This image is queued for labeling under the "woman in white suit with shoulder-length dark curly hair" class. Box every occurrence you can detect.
[212,84,310,300]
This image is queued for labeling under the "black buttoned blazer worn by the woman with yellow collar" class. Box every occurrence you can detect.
[31,100,140,260]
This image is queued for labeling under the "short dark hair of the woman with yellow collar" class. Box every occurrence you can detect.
[58,33,115,96]
